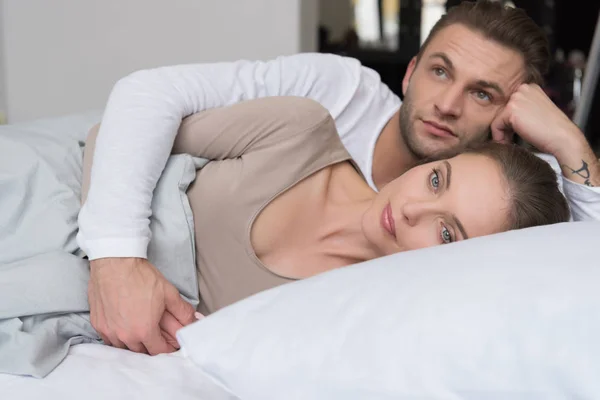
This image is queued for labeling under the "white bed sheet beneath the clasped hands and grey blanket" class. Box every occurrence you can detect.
[0,344,239,400]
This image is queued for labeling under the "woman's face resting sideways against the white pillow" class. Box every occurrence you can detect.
[362,154,509,256]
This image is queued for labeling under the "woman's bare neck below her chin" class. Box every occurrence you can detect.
[316,163,378,263]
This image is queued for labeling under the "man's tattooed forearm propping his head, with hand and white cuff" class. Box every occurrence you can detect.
[492,84,600,221]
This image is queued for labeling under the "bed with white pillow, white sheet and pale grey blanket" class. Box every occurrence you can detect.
[0,112,600,400]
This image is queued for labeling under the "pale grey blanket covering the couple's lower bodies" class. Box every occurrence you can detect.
[0,113,206,377]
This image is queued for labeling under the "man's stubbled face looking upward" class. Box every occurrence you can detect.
[400,24,525,158]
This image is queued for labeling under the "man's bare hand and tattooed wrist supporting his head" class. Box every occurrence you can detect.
[491,84,600,186]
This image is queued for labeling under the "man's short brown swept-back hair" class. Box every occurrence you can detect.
[417,0,550,85]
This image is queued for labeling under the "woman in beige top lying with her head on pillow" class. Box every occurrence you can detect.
[84,97,569,314]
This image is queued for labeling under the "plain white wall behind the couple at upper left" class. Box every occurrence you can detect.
[0,0,318,122]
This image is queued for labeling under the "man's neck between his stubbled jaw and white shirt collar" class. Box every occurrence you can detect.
[371,111,417,190]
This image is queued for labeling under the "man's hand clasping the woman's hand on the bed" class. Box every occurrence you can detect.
[88,258,195,355]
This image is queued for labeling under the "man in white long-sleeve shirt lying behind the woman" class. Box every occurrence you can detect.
[78,1,600,354]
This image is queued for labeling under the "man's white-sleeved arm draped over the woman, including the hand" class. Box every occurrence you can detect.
[77,54,360,354]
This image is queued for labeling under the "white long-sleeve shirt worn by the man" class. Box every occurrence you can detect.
[77,54,600,260]
